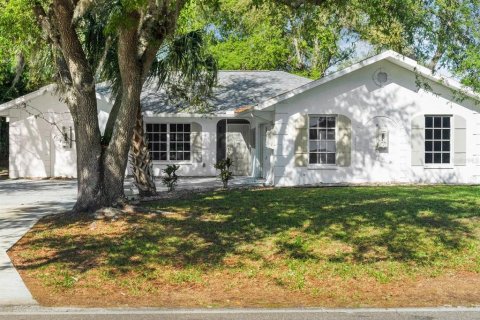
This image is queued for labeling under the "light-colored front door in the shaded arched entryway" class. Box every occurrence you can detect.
[227,124,252,176]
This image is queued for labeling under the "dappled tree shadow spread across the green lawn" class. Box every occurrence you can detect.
[15,186,480,272]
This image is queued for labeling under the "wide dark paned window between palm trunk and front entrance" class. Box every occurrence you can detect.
[146,123,191,161]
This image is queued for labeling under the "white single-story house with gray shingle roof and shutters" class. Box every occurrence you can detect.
[0,51,480,186]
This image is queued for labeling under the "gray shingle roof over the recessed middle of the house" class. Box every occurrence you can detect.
[97,71,311,113]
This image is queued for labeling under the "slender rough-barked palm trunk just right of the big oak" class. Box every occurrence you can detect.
[130,108,157,197]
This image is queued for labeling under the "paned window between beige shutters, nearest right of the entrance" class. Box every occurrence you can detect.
[308,116,337,164]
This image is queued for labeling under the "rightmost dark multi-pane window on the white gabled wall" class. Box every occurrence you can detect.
[425,116,451,164]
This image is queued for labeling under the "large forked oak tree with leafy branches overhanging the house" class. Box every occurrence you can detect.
[0,0,480,215]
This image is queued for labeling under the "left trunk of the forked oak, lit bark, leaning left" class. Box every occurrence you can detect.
[50,0,111,212]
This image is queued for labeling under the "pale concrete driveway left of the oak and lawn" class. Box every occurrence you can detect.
[0,180,77,305]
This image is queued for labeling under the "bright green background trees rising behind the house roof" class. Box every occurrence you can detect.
[180,0,355,78]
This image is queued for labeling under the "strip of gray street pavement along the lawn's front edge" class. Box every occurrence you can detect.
[0,308,480,320]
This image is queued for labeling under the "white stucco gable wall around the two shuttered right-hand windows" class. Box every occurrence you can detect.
[267,61,480,186]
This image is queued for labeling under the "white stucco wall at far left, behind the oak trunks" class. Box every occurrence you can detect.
[4,92,110,179]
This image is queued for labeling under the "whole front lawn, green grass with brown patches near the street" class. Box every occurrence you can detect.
[9,186,480,307]
